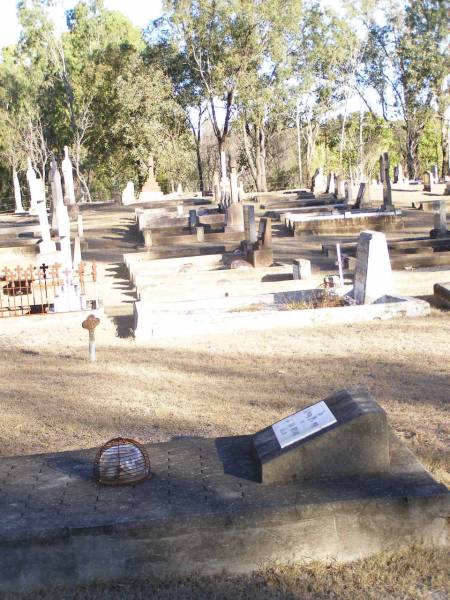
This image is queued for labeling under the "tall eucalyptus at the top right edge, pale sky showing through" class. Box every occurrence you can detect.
[359,0,449,179]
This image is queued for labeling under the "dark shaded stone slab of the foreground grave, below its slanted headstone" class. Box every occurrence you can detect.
[0,392,450,593]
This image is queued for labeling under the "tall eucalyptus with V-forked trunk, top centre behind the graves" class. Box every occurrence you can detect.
[164,0,301,176]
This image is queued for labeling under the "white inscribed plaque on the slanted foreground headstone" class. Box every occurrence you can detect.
[272,400,337,448]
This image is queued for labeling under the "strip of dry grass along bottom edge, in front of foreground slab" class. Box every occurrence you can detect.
[5,547,450,600]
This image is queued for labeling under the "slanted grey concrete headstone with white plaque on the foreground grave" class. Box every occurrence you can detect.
[252,390,390,484]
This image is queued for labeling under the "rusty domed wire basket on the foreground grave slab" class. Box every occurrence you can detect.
[94,437,152,485]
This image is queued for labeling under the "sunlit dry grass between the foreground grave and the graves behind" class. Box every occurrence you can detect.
[0,311,450,484]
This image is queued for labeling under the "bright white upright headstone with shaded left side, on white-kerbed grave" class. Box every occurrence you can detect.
[353,231,394,304]
